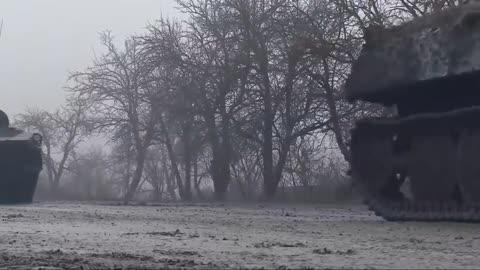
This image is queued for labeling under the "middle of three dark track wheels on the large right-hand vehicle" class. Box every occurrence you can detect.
[408,135,457,203]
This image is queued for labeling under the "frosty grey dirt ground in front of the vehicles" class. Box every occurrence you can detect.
[0,203,480,269]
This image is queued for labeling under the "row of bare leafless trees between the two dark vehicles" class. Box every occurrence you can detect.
[12,0,455,202]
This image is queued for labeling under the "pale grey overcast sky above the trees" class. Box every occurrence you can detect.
[0,0,182,118]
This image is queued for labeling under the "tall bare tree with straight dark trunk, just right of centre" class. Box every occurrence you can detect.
[228,0,348,199]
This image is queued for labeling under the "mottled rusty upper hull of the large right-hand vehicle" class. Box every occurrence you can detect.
[345,3,480,100]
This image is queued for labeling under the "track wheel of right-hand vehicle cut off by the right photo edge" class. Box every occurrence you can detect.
[457,130,480,203]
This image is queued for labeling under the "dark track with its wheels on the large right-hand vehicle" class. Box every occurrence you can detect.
[350,106,480,222]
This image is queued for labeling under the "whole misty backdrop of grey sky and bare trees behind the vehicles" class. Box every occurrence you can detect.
[0,0,420,203]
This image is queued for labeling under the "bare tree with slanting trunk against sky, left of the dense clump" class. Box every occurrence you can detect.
[70,32,157,202]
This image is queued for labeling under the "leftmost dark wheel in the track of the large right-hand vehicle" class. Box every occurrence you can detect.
[351,126,393,198]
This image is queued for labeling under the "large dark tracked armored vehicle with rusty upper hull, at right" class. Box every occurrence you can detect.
[345,2,480,222]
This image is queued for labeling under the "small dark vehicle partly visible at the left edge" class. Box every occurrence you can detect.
[0,111,42,204]
